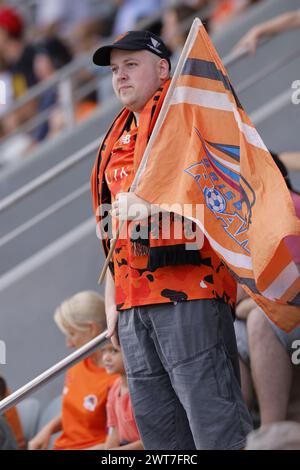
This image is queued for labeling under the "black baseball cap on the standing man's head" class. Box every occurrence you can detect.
[93,31,171,69]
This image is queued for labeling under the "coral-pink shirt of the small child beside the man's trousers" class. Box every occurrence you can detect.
[107,378,140,444]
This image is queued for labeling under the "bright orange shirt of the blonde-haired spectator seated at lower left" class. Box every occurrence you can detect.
[54,358,117,450]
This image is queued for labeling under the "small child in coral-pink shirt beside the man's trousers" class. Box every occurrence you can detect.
[102,343,144,450]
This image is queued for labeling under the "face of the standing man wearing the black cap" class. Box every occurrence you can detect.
[110,49,168,113]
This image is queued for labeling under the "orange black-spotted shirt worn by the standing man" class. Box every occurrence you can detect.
[105,119,236,310]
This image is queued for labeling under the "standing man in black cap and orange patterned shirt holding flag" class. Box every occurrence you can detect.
[91,20,255,450]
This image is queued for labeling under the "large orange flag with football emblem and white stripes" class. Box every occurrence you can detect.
[135,19,300,331]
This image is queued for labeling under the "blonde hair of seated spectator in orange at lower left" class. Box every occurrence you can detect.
[54,291,106,334]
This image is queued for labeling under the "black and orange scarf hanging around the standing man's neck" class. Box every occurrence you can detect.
[91,80,201,272]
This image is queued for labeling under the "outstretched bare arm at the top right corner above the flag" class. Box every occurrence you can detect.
[234,10,300,54]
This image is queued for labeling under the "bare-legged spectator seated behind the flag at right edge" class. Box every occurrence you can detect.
[235,153,300,425]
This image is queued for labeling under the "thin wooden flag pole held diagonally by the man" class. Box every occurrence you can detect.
[98,18,202,284]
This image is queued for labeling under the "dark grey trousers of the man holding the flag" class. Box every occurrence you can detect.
[118,299,252,450]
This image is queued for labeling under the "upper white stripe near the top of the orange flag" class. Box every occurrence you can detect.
[170,86,267,150]
